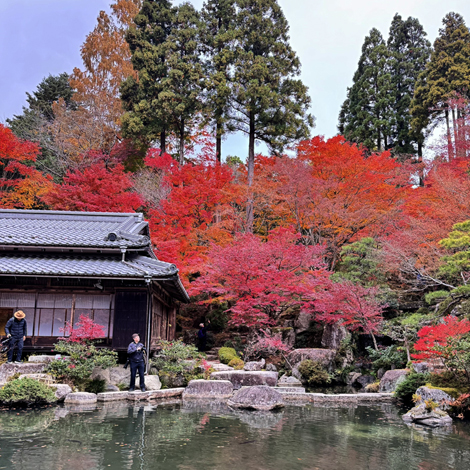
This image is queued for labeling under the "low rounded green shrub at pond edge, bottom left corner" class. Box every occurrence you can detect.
[0,377,57,406]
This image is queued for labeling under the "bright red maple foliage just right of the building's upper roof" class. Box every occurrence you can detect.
[145,148,241,277]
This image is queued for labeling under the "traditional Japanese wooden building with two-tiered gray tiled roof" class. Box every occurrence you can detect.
[0,209,189,351]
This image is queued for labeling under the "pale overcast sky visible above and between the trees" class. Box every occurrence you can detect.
[0,0,470,158]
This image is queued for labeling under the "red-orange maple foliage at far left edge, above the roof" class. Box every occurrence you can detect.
[0,124,52,209]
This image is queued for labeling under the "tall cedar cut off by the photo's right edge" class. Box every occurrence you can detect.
[411,13,470,158]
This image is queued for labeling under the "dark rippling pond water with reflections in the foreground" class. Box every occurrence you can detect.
[0,402,470,470]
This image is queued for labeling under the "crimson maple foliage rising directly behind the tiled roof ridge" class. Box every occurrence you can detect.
[43,163,142,212]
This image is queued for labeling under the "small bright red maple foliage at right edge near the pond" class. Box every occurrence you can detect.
[411,316,470,361]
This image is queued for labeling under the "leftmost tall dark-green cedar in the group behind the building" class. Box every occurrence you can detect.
[121,0,176,152]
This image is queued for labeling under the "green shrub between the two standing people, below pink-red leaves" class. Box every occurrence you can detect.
[45,341,117,391]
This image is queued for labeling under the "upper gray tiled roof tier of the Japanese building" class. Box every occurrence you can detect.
[0,209,150,249]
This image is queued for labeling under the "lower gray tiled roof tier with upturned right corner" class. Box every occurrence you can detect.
[0,252,189,302]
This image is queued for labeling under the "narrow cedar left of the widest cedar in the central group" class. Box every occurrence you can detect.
[201,0,237,162]
